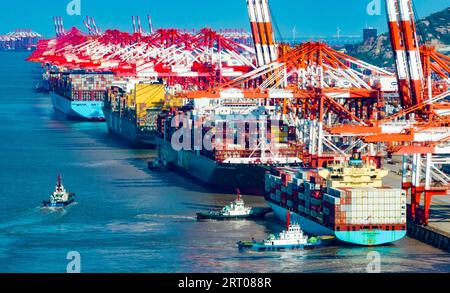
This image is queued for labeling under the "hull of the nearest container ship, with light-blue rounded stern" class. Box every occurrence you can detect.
[267,201,406,246]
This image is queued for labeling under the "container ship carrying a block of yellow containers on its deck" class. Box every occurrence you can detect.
[103,81,181,148]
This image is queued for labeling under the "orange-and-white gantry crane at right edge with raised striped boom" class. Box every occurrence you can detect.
[331,0,450,224]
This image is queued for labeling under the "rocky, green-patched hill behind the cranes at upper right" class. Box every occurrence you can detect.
[346,7,450,67]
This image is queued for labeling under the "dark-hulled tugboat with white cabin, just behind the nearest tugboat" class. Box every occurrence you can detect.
[197,189,272,220]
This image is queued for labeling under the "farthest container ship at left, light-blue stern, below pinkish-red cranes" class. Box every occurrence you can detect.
[48,71,114,121]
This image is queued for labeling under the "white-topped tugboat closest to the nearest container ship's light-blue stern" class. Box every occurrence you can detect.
[237,213,332,251]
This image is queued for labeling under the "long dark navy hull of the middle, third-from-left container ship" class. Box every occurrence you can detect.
[156,138,268,195]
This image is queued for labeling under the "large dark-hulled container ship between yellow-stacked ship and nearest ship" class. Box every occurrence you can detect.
[157,99,303,195]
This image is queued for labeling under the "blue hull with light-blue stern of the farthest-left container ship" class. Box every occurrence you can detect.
[50,92,105,121]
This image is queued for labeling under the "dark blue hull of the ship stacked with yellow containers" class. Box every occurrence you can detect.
[103,108,156,148]
